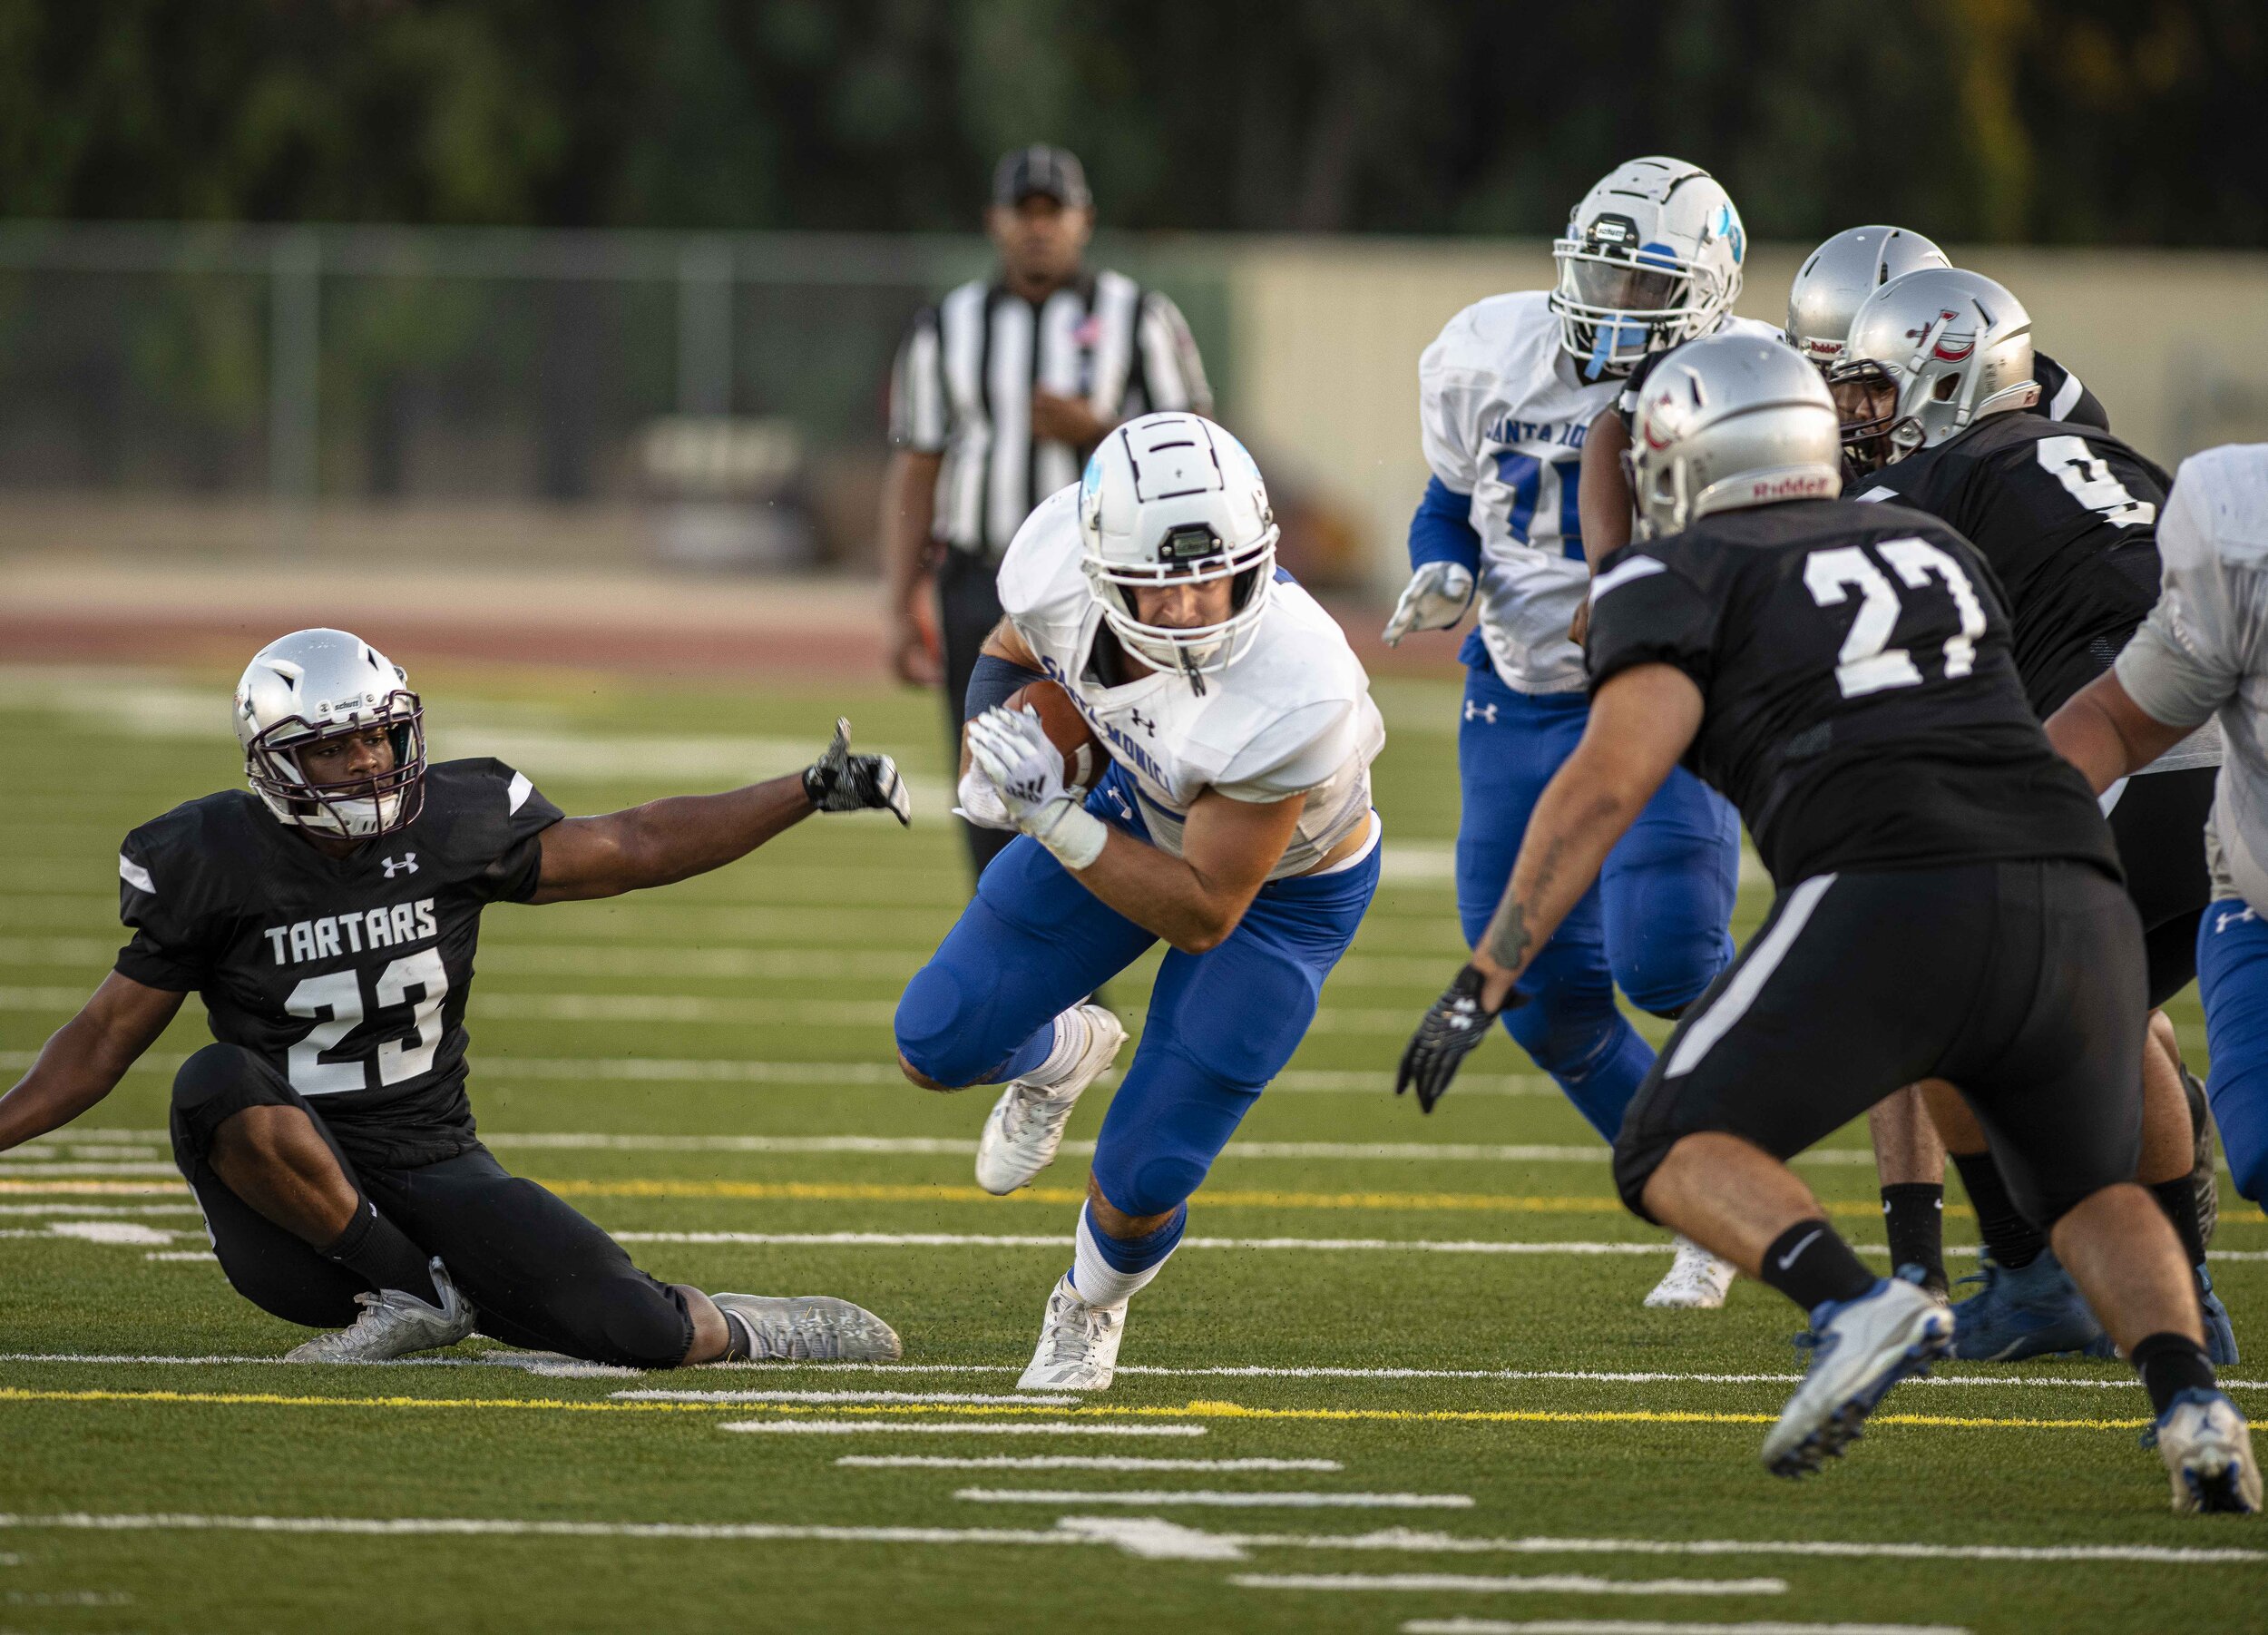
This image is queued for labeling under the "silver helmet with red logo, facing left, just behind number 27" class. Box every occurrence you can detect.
[1828,268,2039,472]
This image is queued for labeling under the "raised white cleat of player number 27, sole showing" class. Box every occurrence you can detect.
[1765,1277,1953,1476]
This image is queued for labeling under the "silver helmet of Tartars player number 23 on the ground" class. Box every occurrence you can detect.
[236,631,426,839]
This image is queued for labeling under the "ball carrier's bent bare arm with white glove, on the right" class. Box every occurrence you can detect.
[966,710,1306,955]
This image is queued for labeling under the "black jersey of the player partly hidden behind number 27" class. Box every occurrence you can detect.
[1844,415,2173,719]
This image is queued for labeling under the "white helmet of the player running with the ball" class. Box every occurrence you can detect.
[1080,413,1277,691]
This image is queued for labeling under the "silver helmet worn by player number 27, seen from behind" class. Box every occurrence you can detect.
[1622,336,1842,540]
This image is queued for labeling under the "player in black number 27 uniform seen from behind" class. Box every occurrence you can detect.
[1397,338,2262,1511]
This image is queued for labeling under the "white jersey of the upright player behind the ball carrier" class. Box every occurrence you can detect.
[1418,290,1778,691]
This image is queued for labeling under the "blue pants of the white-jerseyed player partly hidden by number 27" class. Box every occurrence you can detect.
[1456,667,1740,1141]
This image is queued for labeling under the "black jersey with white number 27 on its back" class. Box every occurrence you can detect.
[1590,499,2118,886]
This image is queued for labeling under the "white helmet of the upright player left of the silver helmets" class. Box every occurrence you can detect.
[1551,159,1749,381]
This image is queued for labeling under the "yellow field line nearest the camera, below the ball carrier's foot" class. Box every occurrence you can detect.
[0,1385,2150,1431]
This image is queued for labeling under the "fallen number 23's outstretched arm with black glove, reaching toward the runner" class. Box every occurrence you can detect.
[529,721,912,903]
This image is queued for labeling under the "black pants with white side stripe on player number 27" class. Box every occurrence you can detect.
[1615,859,2146,1229]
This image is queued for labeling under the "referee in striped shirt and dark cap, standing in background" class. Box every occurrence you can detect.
[883,147,1214,873]
